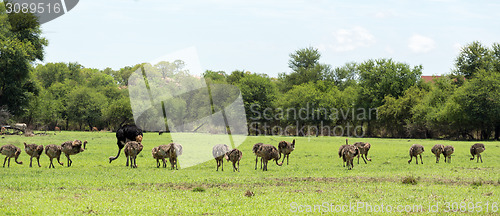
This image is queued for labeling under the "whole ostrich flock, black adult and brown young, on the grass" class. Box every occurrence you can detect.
[0,125,485,172]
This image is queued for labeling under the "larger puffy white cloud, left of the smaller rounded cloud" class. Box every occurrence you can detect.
[320,26,375,52]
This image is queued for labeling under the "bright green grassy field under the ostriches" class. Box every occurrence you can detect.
[0,131,500,215]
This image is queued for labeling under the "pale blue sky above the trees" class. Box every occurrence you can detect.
[38,0,500,77]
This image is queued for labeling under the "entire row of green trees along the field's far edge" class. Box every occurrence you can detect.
[0,4,500,140]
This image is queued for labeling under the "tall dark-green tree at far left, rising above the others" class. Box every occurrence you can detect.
[0,2,47,115]
